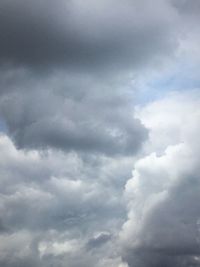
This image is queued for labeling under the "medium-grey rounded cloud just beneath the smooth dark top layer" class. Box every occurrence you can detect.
[0,71,147,155]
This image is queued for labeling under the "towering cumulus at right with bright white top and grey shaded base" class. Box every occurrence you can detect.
[121,93,200,267]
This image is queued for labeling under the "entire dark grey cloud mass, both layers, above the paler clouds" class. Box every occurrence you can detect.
[0,0,180,156]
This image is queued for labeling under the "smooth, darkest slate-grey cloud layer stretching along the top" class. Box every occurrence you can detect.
[0,0,177,71]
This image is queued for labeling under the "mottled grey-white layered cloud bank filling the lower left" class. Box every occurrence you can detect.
[0,134,132,267]
